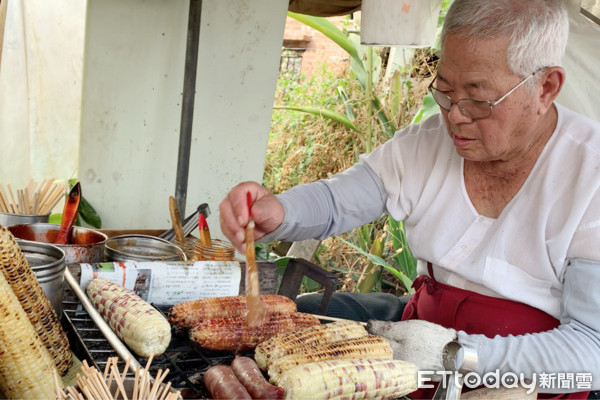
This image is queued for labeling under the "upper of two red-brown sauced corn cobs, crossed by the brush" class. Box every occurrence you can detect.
[169,294,296,328]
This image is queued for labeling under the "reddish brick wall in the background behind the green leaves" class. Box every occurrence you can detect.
[283,17,351,77]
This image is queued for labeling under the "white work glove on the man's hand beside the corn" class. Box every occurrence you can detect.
[367,319,456,371]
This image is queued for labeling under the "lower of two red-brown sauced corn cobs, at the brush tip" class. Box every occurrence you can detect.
[189,312,320,351]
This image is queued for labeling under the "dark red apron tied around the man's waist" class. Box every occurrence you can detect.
[402,263,589,399]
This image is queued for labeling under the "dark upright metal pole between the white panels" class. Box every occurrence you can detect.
[175,0,202,215]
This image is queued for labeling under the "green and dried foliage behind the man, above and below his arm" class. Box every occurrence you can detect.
[263,11,451,292]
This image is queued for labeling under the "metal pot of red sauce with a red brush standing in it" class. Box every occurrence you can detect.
[8,223,108,264]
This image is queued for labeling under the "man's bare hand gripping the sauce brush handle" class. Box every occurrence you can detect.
[219,182,285,253]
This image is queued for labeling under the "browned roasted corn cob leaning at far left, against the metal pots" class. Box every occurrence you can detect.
[0,227,73,375]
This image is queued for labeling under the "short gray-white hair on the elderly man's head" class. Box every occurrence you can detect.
[441,0,569,77]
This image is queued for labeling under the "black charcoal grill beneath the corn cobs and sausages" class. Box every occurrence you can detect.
[63,259,337,399]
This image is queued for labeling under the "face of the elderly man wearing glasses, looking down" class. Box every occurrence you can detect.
[435,36,539,161]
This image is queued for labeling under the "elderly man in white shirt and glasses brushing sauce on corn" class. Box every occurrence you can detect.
[220,0,600,398]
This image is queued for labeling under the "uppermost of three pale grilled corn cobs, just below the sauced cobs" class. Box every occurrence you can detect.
[254,321,367,370]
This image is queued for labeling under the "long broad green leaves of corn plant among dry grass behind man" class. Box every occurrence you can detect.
[274,7,450,293]
